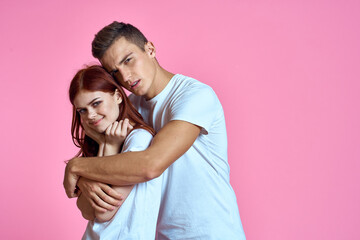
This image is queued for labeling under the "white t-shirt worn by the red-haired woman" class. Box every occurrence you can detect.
[82,128,162,240]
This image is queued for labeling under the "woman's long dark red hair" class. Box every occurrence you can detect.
[69,65,155,157]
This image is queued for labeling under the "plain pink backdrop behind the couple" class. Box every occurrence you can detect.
[0,0,360,240]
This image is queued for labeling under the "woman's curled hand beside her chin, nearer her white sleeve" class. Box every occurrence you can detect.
[105,118,133,151]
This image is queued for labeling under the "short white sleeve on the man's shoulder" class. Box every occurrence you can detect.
[170,83,222,134]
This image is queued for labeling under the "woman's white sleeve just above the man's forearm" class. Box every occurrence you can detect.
[121,128,153,152]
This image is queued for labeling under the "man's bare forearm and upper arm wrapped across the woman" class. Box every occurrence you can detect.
[64,120,201,197]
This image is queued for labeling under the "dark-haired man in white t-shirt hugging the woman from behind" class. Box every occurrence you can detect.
[64,22,245,240]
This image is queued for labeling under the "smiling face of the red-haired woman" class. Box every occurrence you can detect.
[74,90,122,133]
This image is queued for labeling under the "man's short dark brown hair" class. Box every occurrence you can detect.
[91,21,148,59]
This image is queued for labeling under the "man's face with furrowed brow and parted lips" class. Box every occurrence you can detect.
[100,37,157,99]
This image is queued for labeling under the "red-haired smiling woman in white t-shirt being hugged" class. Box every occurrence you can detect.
[69,66,162,239]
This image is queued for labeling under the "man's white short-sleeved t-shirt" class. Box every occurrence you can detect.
[130,74,245,240]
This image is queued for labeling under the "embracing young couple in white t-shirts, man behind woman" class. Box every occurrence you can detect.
[64,22,245,240]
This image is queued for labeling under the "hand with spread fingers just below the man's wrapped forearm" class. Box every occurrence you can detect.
[77,177,123,213]
